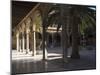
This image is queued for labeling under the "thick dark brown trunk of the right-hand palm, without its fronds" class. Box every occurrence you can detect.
[71,10,80,59]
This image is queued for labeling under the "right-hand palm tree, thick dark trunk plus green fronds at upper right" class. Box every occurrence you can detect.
[71,6,95,58]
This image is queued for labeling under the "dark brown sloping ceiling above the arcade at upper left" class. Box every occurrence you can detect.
[11,1,37,28]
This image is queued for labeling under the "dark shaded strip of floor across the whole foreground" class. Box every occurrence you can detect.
[12,58,96,75]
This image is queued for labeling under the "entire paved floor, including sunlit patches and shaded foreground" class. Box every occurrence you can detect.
[12,48,96,74]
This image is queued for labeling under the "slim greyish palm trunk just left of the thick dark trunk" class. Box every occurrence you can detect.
[61,5,69,62]
